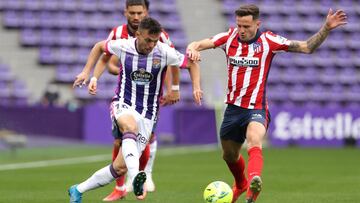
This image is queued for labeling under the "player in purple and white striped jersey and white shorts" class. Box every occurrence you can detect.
[68,18,202,203]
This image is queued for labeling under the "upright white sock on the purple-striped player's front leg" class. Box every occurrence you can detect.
[121,138,140,182]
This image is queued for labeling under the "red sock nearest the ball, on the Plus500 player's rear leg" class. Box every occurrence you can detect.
[226,155,247,189]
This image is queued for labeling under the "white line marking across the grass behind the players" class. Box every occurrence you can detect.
[0,145,217,171]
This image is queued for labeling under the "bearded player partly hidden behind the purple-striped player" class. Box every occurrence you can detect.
[74,0,179,201]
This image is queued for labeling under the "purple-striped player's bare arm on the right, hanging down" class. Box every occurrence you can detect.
[188,60,203,105]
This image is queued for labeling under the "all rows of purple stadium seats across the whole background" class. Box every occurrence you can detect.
[0,0,360,106]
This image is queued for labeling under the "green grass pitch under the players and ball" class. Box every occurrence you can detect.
[0,146,360,203]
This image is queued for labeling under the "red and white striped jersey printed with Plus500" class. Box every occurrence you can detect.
[211,28,290,109]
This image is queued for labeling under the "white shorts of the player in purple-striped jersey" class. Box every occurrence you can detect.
[110,101,154,152]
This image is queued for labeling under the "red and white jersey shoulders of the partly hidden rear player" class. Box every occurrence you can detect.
[107,24,174,47]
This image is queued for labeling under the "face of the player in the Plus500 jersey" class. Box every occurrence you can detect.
[236,15,260,42]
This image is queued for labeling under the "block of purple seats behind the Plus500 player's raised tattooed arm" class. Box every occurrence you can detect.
[221,0,360,107]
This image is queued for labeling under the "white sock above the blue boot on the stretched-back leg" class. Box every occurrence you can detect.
[77,165,115,193]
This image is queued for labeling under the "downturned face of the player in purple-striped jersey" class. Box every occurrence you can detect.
[136,30,160,55]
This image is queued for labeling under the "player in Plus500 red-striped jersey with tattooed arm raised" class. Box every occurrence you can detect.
[187,5,346,203]
